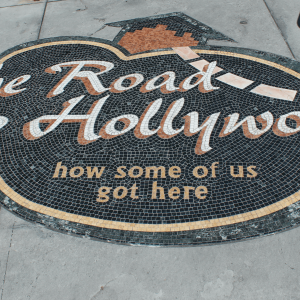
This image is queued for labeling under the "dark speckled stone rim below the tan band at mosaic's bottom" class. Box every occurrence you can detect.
[0,191,300,247]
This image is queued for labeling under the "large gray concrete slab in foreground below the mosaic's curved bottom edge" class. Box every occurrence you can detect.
[0,210,300,300]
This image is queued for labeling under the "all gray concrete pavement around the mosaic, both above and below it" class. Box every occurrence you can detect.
[0,0,300,300]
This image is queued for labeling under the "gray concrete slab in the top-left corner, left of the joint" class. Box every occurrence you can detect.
[0,0,45,52]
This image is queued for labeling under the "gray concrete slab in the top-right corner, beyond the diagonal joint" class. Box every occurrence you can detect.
[265,0,300,60]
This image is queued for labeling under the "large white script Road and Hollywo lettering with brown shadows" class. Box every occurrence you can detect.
[0,61,300,155]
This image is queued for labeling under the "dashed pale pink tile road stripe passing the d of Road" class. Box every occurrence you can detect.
[173,47,297,101]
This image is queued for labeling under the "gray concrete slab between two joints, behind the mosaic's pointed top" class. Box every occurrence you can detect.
[41,0,292,58]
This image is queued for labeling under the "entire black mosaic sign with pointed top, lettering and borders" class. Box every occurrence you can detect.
[0,13,300,246]
